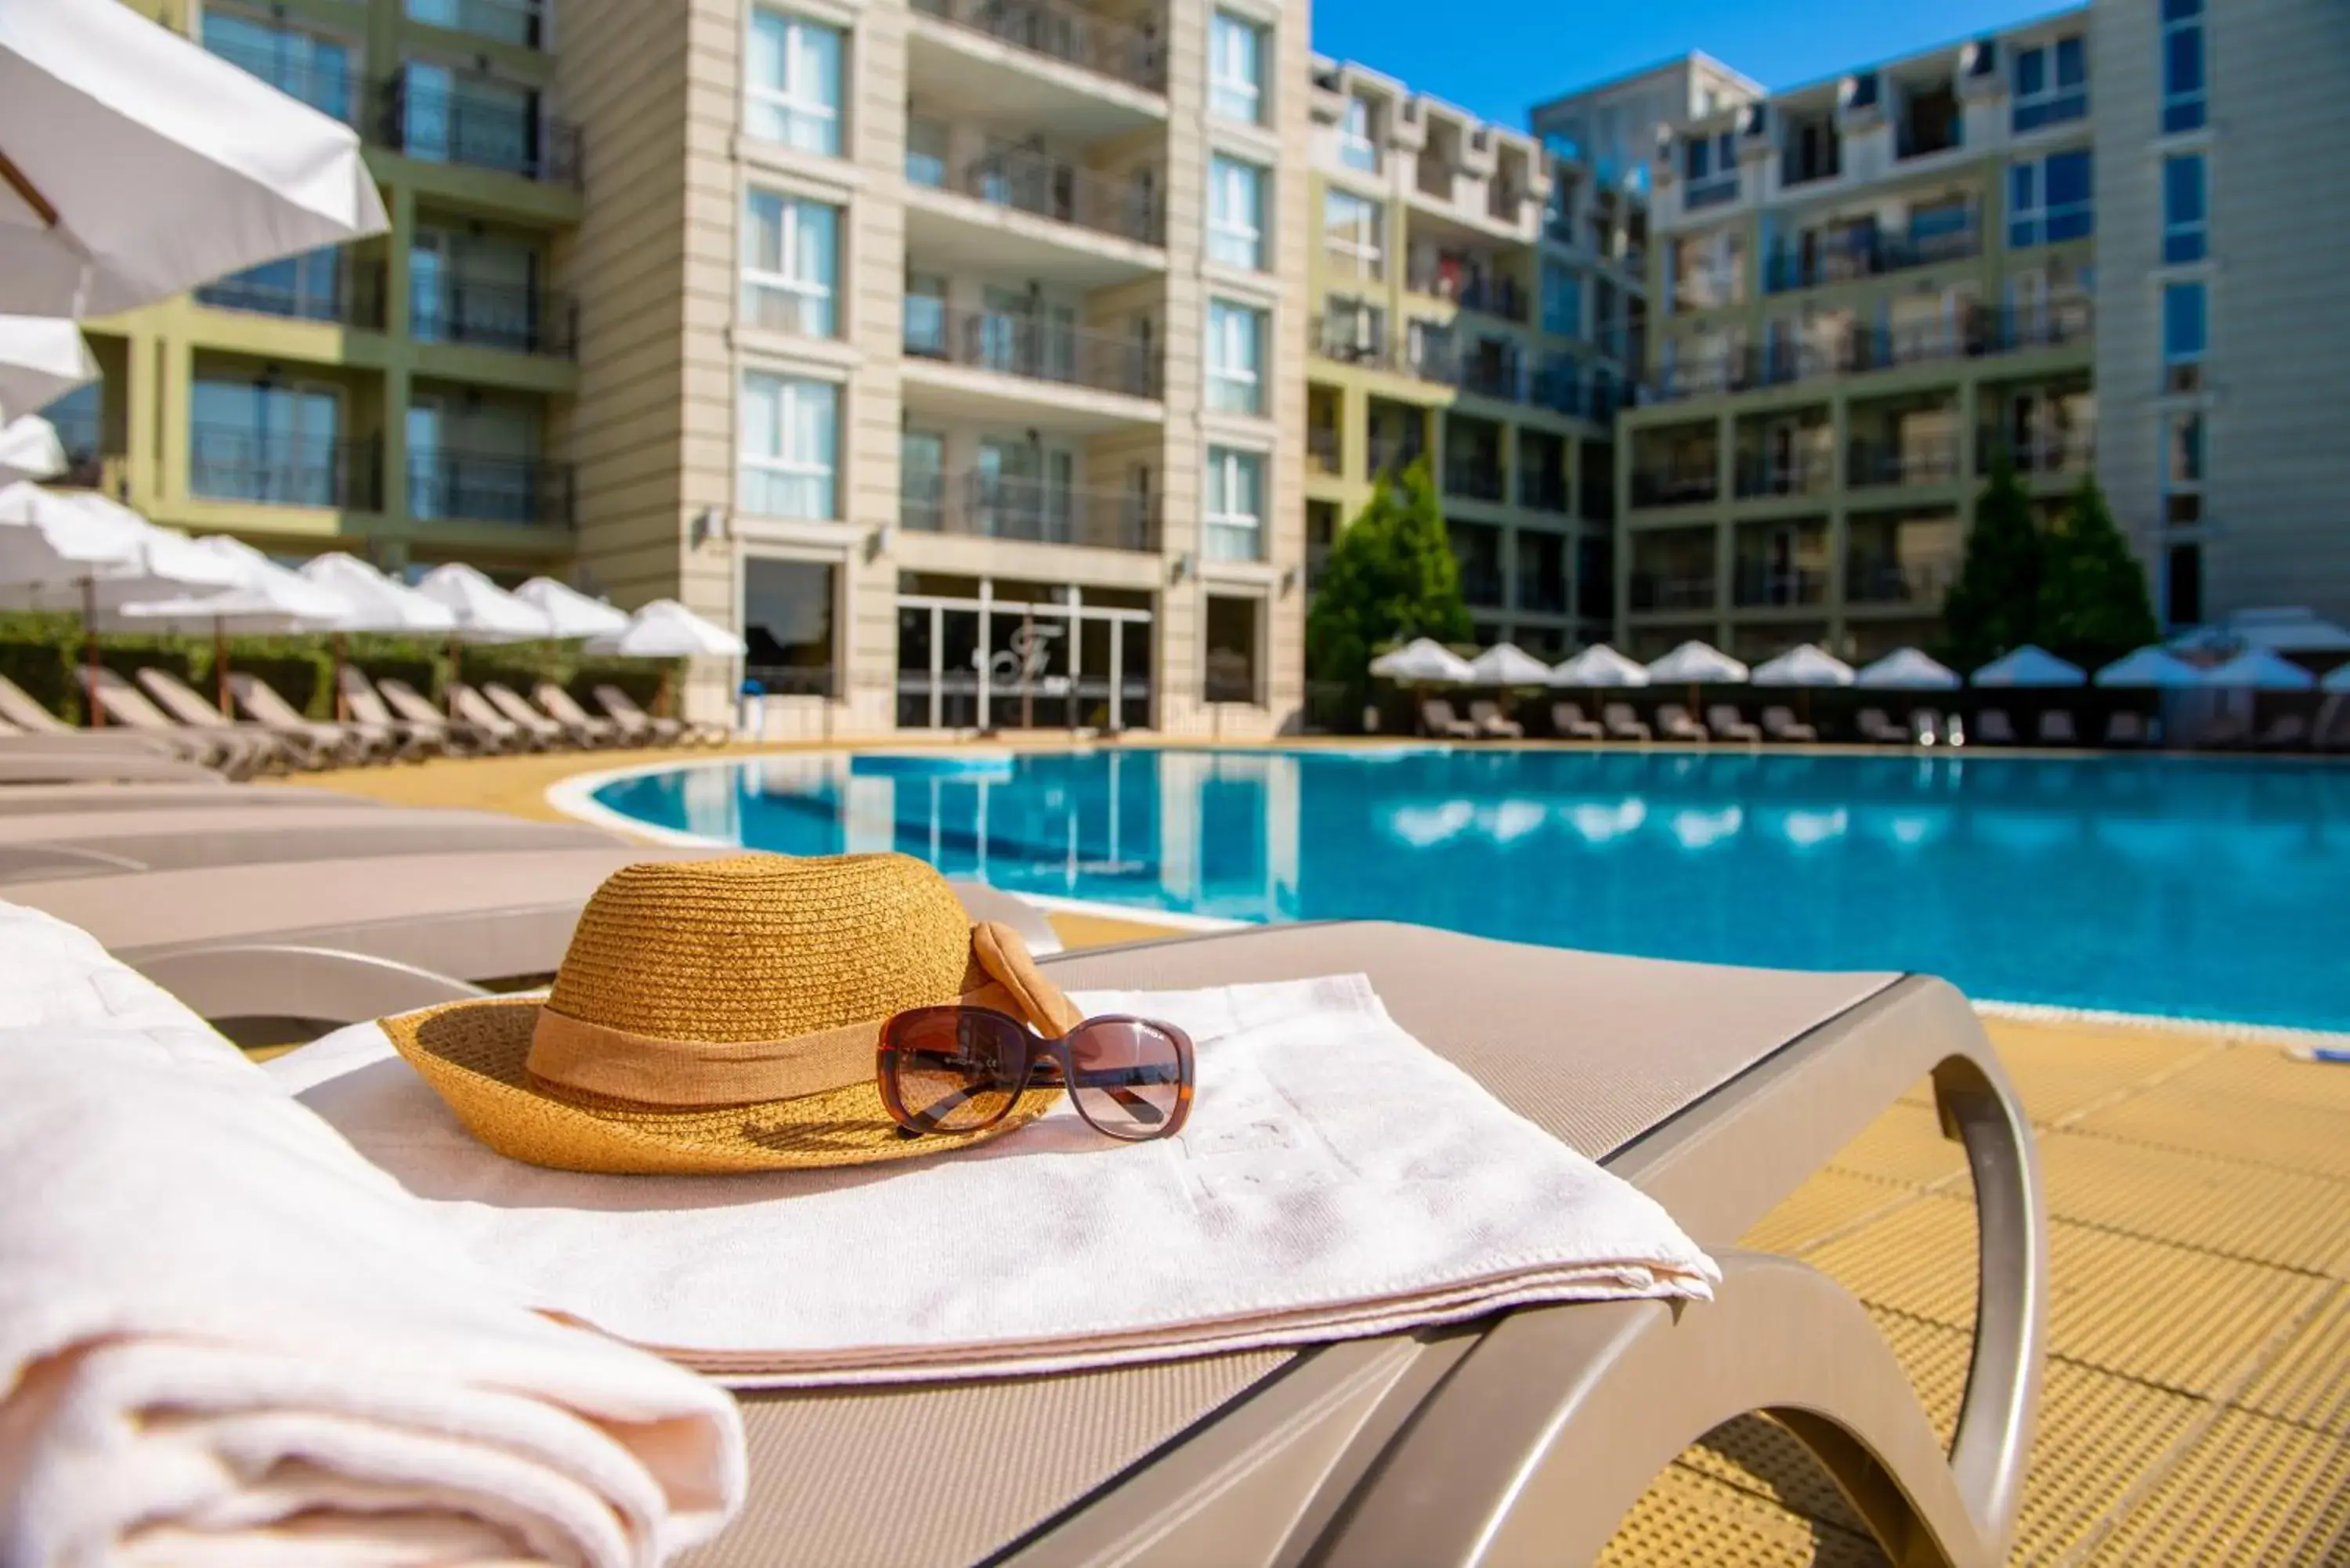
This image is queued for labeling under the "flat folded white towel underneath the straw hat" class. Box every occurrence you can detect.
[268,976,1718,1385]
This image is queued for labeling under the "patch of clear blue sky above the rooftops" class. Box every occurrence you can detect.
[1314,0,2061,125]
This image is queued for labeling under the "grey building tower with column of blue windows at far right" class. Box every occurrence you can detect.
[2089,0,2350,625]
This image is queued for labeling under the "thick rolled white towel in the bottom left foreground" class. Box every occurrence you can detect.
[0,903,743,1568]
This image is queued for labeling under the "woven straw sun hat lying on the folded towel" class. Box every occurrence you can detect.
[383,856,1079,1173]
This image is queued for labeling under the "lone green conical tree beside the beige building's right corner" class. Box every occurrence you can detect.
[1307,458,1469,712]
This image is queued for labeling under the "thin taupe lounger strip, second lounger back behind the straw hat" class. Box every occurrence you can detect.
[0,808,623,898]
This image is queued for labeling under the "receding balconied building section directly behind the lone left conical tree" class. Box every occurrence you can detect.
[1304,59,1643,656]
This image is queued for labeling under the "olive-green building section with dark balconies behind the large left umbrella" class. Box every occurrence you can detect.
[45,0,583,576]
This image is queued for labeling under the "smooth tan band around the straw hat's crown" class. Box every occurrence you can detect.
[524,1006,884,1105]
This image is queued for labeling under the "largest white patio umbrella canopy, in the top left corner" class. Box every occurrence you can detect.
[0,0,390,317]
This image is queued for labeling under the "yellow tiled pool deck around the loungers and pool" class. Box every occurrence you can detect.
[294,745,2350,1568]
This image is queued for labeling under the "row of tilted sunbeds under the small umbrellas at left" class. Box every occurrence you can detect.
[0,665,726,780]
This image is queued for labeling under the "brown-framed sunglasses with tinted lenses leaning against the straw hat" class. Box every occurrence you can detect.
[881,1004,1191,1143]
